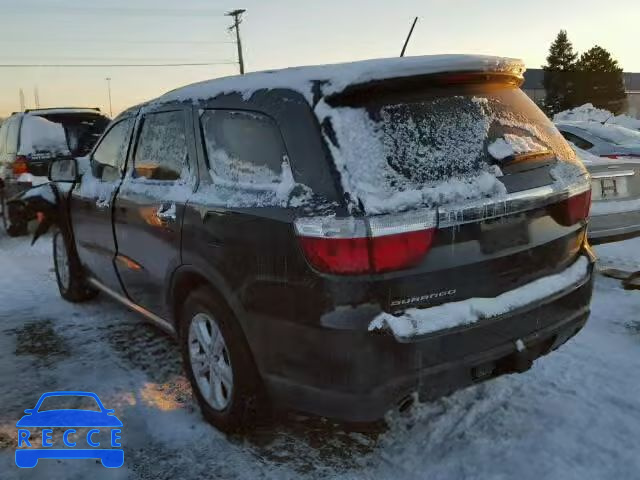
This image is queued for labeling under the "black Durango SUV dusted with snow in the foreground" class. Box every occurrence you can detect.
[45,55,593,431]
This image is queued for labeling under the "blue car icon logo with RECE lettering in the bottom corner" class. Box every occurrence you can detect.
[16,391,124,468]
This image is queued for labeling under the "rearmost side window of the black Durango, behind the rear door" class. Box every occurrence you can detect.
[200,110,287,187]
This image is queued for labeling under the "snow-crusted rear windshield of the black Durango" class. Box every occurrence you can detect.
[323,85,574,213]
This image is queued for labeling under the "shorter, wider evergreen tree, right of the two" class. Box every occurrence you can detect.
[575,45,627,114]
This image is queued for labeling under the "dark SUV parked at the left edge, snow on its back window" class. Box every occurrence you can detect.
[0,108,109,236]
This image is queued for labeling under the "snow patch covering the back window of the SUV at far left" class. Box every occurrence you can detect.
[18,115,71,155]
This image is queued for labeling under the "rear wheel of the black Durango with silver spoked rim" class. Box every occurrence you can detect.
[179,287,269,433]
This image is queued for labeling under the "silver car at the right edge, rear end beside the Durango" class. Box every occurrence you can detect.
[572,141,640,244]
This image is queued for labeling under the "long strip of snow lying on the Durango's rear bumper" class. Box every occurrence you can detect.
[369,256,589,339]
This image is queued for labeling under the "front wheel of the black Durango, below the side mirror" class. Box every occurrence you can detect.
[53,229,98,303]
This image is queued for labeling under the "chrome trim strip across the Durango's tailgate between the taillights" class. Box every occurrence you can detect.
[438,177,591,228]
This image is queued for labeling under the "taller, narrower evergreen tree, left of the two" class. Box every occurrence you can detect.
[543,30,578,116]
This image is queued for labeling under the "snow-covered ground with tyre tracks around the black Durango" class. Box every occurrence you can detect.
[0,234,640,480]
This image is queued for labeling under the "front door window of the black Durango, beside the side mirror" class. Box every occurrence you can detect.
[92,118,133,181]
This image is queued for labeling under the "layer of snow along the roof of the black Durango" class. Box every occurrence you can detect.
[151,54,525,103]
